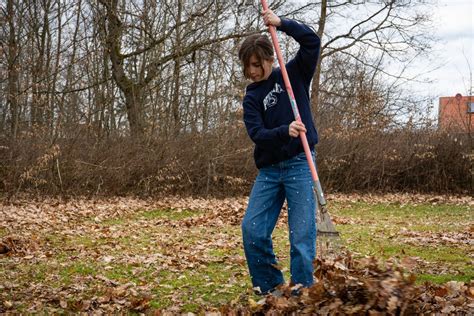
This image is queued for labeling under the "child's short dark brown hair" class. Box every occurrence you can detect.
[239,34,273,78]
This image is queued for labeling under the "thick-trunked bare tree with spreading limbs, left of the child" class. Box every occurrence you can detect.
[94,0,258,137]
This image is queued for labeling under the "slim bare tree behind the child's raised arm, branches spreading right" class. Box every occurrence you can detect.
[312,0,432,118]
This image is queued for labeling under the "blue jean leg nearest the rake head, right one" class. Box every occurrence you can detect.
[284,154,316,287]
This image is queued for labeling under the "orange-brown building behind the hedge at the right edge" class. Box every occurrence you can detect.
[438,93,474,133]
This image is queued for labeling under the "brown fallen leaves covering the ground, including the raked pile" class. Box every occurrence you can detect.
[0,194,474,315]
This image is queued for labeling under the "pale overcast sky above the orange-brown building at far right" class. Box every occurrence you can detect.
[414,0,474,100]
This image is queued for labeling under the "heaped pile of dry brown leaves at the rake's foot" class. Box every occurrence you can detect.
[220,255,474,315]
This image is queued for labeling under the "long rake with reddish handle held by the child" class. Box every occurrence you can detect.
[261,0,339,244]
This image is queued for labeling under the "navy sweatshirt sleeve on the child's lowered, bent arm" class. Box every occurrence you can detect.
[243,97,290,150]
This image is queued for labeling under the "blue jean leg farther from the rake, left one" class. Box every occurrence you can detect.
[242,167,285,293]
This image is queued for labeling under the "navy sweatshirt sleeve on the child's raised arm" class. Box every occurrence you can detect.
[277,18,321,83]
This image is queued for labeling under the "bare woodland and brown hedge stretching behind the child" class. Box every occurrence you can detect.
[0,0,474,196]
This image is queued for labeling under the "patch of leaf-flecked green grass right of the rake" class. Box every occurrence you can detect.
[333,203,474,283]
